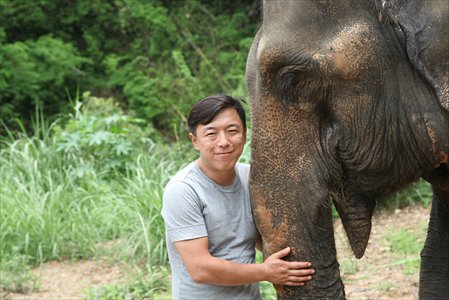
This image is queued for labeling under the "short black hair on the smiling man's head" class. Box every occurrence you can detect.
[187,94,246,135]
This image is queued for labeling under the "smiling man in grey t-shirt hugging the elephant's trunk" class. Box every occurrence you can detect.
[162,95,314,299]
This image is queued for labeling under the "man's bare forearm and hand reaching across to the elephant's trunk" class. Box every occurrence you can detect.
[175,237,314,286]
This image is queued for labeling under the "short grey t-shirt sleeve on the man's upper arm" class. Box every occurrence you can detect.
[162,181,207,242]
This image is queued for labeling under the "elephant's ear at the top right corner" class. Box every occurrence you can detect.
[390,1,449,111]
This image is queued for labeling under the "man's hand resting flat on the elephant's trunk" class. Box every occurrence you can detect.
[263,247,315,286]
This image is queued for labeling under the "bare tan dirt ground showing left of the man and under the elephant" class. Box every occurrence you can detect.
[3,207,429,300]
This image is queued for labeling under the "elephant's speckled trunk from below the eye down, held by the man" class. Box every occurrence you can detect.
[250,97,345,299]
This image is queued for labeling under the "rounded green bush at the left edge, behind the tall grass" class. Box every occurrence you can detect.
[0,35,89,130]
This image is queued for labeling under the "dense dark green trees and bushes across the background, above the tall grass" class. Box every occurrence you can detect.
[0,0,258,138]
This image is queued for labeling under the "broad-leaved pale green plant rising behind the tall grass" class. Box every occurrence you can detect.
[53,93,153,178]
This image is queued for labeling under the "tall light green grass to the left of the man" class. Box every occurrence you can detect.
[0,107,192,265]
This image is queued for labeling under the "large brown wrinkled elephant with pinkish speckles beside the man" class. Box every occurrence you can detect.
[246,0,449,299]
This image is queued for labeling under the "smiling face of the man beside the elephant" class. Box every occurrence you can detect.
[189,108,246,175]
